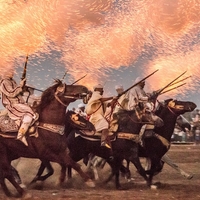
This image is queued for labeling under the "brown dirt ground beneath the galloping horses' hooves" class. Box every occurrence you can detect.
[0,145,200,200]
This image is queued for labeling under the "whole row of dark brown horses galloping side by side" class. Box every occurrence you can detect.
[0,80,196,196]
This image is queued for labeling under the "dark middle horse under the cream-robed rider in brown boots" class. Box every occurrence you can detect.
[32,104,162,188]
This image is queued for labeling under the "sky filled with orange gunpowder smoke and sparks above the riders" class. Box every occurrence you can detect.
[0,0,200,111]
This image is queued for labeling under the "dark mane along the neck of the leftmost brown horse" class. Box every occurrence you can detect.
[37,79,62,112]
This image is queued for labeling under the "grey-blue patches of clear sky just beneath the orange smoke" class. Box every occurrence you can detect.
[0,56,200,109]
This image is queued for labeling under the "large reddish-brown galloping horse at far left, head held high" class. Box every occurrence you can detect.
[0,80,94,196]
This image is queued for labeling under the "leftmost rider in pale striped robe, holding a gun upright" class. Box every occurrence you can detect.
[0,71,36,146]
